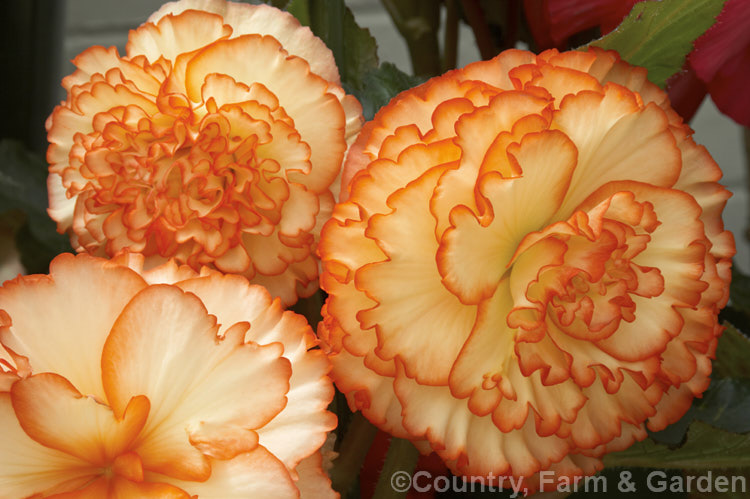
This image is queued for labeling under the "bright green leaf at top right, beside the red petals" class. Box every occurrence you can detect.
[590,0,724,88]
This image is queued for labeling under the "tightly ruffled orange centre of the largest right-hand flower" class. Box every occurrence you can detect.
[508,193,664,348]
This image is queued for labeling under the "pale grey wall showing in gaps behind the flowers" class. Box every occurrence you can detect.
[54,0,750,272]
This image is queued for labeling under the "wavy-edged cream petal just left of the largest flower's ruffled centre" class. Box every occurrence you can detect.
[437,131,577,304]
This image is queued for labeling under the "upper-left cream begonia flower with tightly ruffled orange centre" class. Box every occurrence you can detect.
[47,0,362,305]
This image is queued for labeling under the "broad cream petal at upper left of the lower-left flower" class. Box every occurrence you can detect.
[0,255,146,403]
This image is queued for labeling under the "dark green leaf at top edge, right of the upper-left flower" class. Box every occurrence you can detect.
[287,0,378,92]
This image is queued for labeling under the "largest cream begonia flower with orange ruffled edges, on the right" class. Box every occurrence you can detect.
[318,49,735,490]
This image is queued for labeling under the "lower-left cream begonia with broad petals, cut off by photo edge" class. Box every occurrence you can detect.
[0,254,338,499]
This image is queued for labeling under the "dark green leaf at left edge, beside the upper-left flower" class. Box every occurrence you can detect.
[0,139,72,273]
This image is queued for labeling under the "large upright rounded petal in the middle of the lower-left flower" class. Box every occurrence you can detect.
[97,285,291,480]
